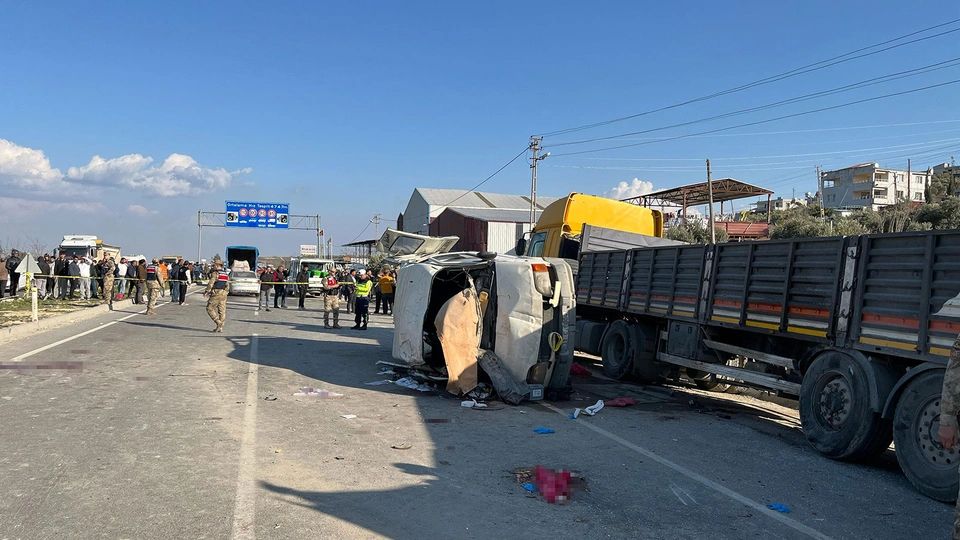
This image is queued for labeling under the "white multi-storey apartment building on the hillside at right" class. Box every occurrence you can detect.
[820,163,931,210]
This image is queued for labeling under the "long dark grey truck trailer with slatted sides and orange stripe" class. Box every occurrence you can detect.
[576,231,960,501]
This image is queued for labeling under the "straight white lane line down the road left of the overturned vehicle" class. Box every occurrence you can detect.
[233,334,260,540]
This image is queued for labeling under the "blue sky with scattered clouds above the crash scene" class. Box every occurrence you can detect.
[0,0,960,256]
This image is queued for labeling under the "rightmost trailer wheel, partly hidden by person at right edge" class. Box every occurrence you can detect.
[893,371,960,502]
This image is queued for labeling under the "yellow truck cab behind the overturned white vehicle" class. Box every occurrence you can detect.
[517,193,663,259]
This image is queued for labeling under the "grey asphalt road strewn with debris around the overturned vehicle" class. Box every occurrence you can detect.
[0,294,953,539]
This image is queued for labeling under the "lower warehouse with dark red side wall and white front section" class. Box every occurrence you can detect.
[430,208,540,255]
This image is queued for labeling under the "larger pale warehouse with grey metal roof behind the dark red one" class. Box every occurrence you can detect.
[397,188,557,234]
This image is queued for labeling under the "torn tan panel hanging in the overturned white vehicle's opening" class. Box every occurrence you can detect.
[434,289,480,395]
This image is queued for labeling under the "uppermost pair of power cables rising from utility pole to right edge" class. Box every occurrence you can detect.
[541,19,960,137]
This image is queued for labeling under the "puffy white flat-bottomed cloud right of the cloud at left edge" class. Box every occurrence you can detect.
[67,154,242,197]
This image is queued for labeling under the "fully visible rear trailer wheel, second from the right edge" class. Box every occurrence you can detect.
[800,351,892,461]
